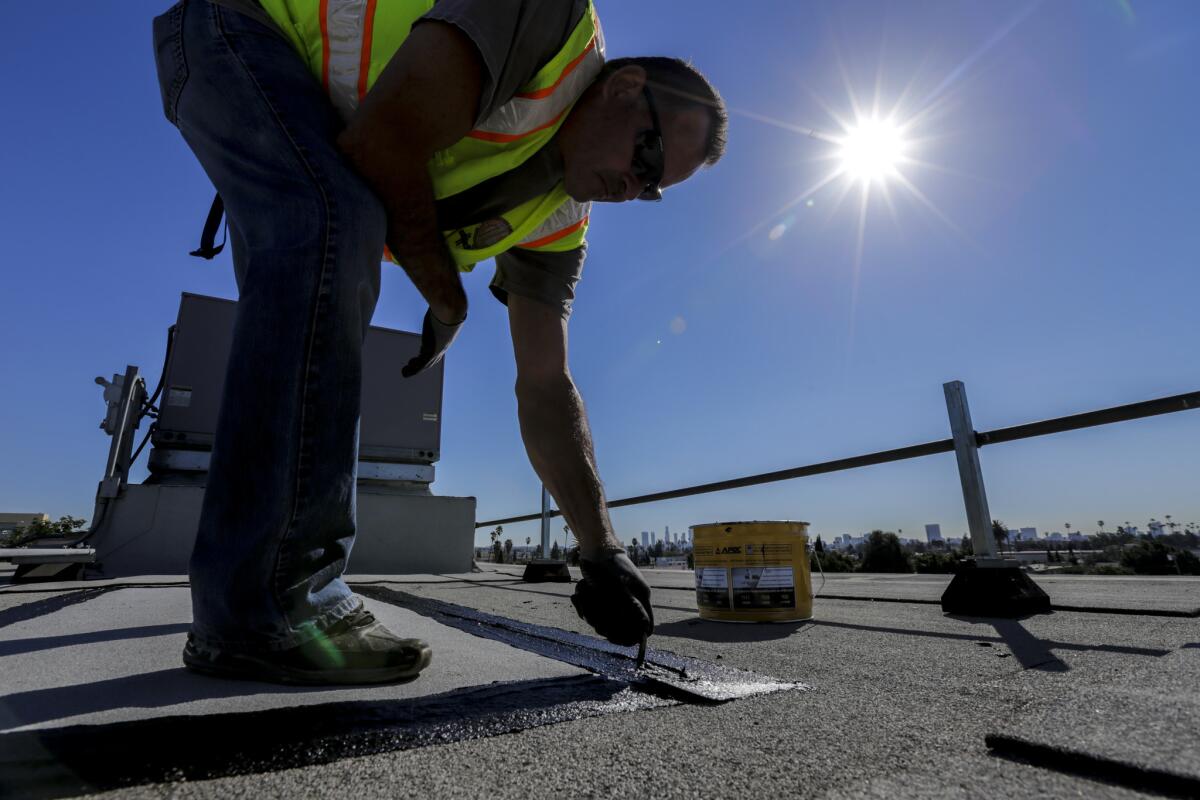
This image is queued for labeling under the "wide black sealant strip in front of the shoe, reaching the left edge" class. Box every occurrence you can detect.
[0,675,678,800]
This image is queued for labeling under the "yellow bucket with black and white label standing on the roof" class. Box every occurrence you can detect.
[691,521,812,622]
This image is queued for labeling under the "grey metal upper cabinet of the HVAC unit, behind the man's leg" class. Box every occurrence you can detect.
[154,293,443,464]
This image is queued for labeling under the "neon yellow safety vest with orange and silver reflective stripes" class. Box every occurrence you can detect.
[260,0,604,271]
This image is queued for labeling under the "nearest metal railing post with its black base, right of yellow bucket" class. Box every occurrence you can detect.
[942,380,1050,616]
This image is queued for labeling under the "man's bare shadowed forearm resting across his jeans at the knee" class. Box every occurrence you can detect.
[338,134,467,324]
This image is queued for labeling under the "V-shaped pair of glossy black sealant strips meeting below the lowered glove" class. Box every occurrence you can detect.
[0,587,809,800]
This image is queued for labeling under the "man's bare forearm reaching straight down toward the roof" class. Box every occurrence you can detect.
[517,374,620,559]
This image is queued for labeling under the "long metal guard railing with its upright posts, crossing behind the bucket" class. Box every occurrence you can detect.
[475,381,1200,566]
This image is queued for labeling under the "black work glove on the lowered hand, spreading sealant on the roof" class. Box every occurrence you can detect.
[571,551,654,646]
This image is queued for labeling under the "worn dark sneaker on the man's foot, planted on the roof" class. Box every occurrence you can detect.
[184,606,433,686]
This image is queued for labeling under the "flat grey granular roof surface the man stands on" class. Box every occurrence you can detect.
[0,565,1200,799]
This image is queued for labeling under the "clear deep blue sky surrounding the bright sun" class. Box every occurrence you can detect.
[0,0,1200,551]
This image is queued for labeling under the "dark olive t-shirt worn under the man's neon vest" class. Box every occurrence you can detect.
[210,0,597,318]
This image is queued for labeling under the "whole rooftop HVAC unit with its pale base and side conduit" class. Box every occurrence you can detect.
[10,294,475,582]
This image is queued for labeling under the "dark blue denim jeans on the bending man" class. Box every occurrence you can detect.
[154,0,386,650]
